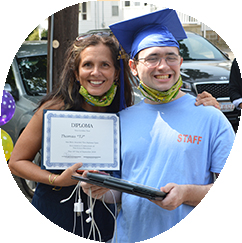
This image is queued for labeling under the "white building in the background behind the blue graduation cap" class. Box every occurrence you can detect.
[79,1,229,49]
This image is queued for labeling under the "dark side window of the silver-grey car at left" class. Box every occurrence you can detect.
[17,56,47,95]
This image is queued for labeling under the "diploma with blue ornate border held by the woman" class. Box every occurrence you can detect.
[41,110,120,170]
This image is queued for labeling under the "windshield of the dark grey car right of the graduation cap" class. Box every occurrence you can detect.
[179,34,226,60]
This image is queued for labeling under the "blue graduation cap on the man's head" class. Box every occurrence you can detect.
[109,8,187,58]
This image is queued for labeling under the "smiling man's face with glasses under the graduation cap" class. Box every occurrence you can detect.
[130,47,183,91]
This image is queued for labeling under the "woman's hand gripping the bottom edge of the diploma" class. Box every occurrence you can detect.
[52,163,82,187]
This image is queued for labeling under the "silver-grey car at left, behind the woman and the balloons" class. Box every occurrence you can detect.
[1,41,47,198]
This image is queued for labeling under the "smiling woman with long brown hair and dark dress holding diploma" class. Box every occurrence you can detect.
[9,33,133,241]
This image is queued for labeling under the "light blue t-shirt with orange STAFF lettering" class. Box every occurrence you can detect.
[114,94,235,243]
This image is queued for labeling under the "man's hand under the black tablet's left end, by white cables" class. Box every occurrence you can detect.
[81,171,110,199]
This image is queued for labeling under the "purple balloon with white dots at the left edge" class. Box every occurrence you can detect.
[0,90,15,126]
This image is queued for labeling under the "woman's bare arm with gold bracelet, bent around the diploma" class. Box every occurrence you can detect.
[9,102,82,186]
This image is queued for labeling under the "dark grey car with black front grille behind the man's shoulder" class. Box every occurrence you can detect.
[179,32,239,126]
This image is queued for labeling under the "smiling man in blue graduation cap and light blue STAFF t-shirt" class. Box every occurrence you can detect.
[83,9,234,243]
